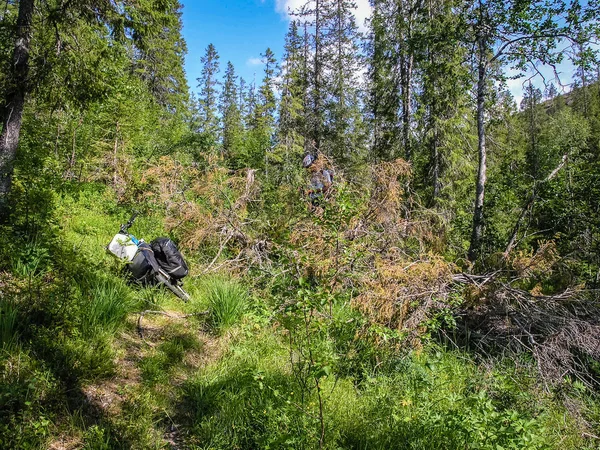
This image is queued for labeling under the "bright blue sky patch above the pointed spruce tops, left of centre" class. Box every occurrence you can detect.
[182,0,288,93]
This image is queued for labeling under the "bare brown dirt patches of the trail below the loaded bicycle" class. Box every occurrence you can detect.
[48,310,226,450]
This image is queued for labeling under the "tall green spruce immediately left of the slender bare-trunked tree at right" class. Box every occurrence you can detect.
[413,0,469,205]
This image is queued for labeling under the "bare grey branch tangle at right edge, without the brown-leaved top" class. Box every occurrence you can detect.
[459,279,600,388]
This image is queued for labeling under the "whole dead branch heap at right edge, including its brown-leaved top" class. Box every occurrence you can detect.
[453,241,600,388]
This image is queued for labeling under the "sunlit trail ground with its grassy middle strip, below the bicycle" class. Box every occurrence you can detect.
[48,300,229,450]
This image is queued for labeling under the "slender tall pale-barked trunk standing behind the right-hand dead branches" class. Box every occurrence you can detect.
[468,33,487,261]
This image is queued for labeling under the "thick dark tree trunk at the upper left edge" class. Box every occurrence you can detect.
[0,0,34,199]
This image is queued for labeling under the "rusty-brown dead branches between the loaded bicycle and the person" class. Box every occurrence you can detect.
[142,157,268,272]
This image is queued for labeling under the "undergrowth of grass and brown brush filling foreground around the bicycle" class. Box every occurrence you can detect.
[0,166,600,450]
